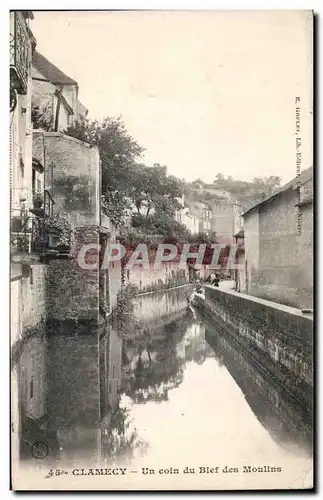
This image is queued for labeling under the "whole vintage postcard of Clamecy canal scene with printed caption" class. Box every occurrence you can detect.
[9,10,314,491]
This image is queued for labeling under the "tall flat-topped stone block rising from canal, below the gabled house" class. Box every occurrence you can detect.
[33,130,121,324]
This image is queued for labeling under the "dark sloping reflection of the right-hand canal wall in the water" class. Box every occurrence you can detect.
[206,325,312,451]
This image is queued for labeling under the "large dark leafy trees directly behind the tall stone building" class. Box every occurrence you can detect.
[66,118,186,234]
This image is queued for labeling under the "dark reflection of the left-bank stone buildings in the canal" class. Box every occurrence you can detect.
[18,331,122,463]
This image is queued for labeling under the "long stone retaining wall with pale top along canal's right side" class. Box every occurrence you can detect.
[204,287,313,405]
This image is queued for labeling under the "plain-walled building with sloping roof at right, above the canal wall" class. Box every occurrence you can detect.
[243,168,313,308]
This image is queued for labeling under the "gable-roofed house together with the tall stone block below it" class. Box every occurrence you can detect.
[32,48,121,324]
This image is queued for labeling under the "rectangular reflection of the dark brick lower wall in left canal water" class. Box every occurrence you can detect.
[46,335,100,464]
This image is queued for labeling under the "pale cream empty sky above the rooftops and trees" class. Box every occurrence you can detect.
[30,11,312,182]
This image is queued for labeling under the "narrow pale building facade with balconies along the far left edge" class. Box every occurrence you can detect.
[9,11,49,345]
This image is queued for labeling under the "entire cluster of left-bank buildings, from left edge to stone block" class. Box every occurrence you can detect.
[10,19,121,345]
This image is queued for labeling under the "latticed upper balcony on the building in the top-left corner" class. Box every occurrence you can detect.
[10,12,31,94]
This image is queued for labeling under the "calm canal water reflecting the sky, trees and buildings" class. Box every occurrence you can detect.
[12,287,312,489]
